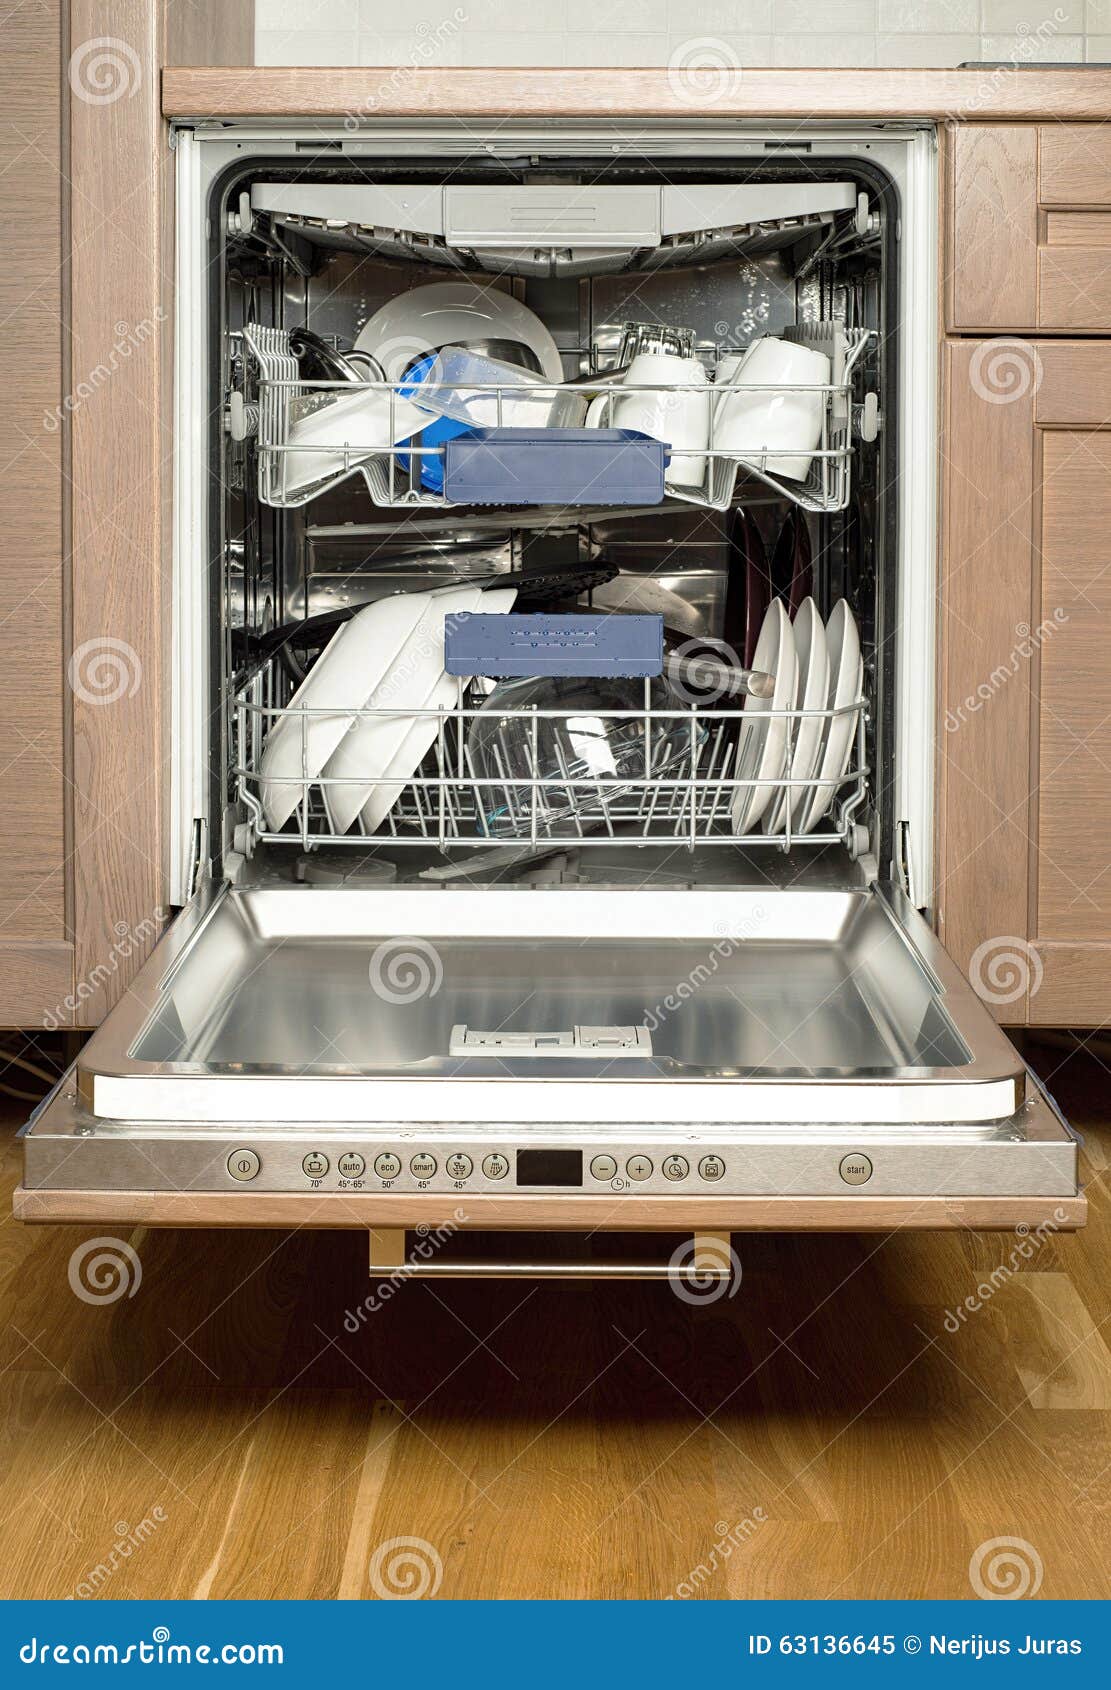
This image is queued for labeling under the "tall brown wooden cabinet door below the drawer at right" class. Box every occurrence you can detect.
[937,340,1111,1026]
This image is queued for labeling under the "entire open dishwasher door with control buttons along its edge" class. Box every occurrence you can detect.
[17,886,1084,1230]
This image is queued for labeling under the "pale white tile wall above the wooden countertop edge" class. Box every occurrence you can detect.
[255,0,1111,66]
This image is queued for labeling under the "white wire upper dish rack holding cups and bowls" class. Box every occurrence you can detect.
[230,323,873,512]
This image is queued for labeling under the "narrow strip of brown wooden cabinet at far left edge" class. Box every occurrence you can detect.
[0,0,73,1026]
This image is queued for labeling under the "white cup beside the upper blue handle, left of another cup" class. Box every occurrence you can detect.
[587,352,710,487]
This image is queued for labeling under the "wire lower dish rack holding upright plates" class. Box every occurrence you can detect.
[232,669,869,857]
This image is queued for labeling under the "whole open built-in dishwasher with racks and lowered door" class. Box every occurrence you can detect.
[17,117,1084,1276]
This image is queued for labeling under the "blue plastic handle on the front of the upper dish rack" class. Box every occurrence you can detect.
[443,428,671,505]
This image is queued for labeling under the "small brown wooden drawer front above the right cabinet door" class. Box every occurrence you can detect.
[945,123,1111,333]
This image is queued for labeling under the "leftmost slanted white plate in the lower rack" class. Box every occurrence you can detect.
[259,593,431,831]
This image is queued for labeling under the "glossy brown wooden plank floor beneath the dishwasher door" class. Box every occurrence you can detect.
[0,1049,1111,1599]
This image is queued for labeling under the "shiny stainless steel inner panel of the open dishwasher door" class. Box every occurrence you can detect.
[67,887,1025,1131]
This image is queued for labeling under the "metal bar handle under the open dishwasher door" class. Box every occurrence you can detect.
[370,1227,739,1286]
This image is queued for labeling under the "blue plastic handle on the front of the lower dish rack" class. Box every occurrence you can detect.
[443,610,663,679]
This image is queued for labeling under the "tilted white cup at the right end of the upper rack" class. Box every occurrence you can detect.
[714,335,830,482]
